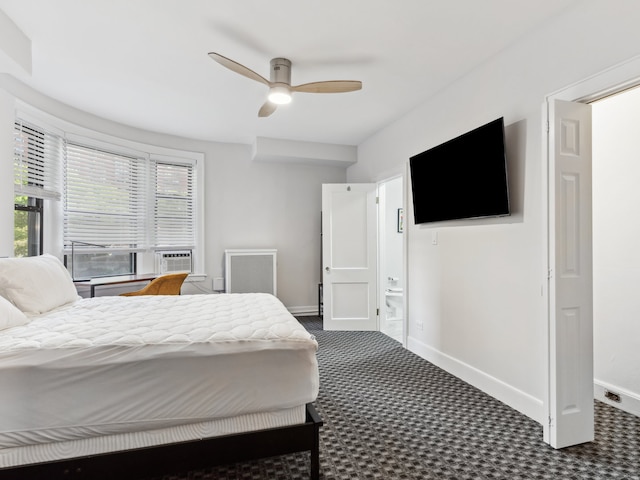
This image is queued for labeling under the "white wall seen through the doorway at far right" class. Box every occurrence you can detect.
[593,85,640,414]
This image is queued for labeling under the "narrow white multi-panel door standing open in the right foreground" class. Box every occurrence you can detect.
[545,100,594,448]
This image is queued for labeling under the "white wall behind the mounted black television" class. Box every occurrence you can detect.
[348,0,640,422]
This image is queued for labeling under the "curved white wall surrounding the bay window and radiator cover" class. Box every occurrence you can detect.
[0,74,346,313]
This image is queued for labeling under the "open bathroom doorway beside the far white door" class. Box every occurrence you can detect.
[378,176,405,343]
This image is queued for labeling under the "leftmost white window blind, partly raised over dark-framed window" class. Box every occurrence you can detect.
[13,120,64,199]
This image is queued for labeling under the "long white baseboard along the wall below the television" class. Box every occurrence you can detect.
[407,337,544,424]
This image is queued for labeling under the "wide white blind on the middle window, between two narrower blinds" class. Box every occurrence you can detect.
[64,142,148,251]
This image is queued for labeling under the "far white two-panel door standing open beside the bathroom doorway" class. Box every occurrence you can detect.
[322,183,378,330]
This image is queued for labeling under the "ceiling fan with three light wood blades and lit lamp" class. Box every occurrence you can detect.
[209,52,362,117]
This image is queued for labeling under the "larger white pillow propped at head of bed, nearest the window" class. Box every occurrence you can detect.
[0,254,78,313]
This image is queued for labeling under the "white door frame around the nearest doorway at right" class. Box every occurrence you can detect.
[541,56,640,443]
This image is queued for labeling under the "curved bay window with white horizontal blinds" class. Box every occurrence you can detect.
[14,116,197,280]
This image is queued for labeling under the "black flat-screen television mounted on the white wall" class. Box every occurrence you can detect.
[410,117,510,224]
